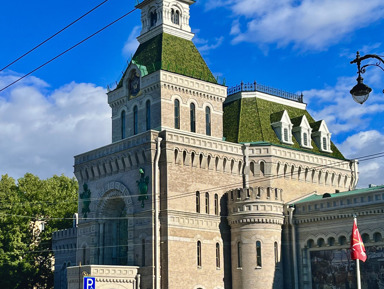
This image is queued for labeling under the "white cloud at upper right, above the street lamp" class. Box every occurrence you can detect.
[205,0,384,50]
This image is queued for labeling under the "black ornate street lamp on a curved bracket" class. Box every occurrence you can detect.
[350,51,384,104]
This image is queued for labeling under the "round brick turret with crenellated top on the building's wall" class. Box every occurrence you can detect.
[227,187,284,289]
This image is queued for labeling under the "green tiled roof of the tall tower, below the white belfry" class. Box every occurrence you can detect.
[117,33,217,88]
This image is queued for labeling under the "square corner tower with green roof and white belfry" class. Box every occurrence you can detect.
[108,0,227,142]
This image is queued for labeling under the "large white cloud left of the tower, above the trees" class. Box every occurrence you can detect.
[0,73,111,178]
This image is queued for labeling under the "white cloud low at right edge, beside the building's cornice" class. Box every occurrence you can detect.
[339,130,384,187]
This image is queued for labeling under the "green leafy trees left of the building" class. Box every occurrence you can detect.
[0,173,78,289]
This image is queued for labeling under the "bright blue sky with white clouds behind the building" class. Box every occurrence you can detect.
[0,0,384,187]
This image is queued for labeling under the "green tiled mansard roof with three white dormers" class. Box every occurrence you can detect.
[223,97,345,159]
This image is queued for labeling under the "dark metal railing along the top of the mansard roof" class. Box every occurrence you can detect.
[227,81,303,103]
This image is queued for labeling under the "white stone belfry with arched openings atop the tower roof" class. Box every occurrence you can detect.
[136,0,195,43]
